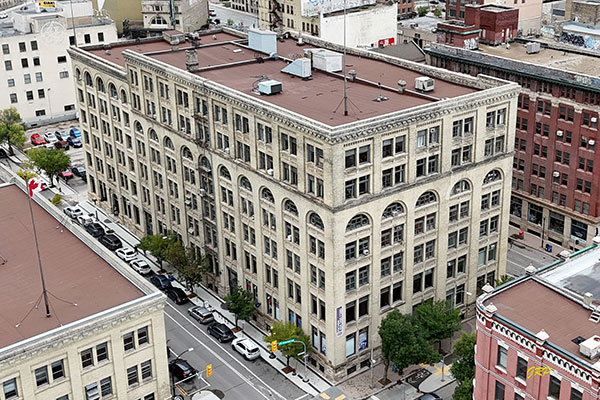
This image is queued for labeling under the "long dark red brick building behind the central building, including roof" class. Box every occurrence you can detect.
[427,44,600,248]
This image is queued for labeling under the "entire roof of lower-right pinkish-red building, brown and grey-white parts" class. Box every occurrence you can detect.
[482,245,600,359]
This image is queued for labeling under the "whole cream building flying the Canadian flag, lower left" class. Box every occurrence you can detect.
[0,183,171,400]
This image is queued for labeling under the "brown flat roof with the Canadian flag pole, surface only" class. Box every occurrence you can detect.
[0,185,144,349]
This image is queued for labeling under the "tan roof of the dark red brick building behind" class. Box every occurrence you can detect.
[425,43,600,90]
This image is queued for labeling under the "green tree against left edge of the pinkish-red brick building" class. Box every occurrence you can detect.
[450,333,477,400]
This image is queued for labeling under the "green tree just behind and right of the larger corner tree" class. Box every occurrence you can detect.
[415,300,460,346]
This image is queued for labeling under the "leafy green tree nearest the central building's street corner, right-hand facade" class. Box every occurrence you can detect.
[379,309,440,382]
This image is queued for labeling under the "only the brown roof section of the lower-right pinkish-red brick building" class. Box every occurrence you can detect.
[483,278,600,358]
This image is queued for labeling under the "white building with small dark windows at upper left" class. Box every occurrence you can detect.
[0,0,117,126]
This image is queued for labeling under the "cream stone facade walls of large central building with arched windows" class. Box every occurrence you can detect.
[72,32,518,380]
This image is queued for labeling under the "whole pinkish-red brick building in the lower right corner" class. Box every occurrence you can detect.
[473,238,600,400]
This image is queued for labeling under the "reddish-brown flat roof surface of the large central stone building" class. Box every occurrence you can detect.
[84,33,479,126]
